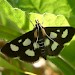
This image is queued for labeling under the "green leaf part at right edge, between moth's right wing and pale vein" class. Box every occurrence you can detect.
[61,39,75,69]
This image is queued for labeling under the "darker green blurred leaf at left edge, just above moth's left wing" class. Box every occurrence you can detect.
[0,21,22,41]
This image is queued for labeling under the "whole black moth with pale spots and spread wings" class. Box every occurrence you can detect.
[1,21,75,62]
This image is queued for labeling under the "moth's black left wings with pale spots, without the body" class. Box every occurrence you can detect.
[1,30,39,62]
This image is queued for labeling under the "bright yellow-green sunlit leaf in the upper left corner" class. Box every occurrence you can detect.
[0,0,25,27]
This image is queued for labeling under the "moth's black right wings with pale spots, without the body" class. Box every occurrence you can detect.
[45,27,75,56]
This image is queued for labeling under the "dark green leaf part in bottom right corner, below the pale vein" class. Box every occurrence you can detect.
[48,57,75,75]
